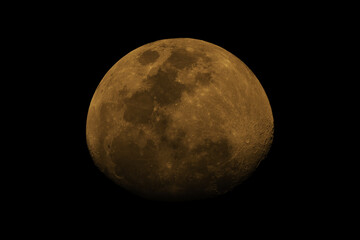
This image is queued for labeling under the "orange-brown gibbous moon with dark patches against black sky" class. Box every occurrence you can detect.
[86,38,274,201]
